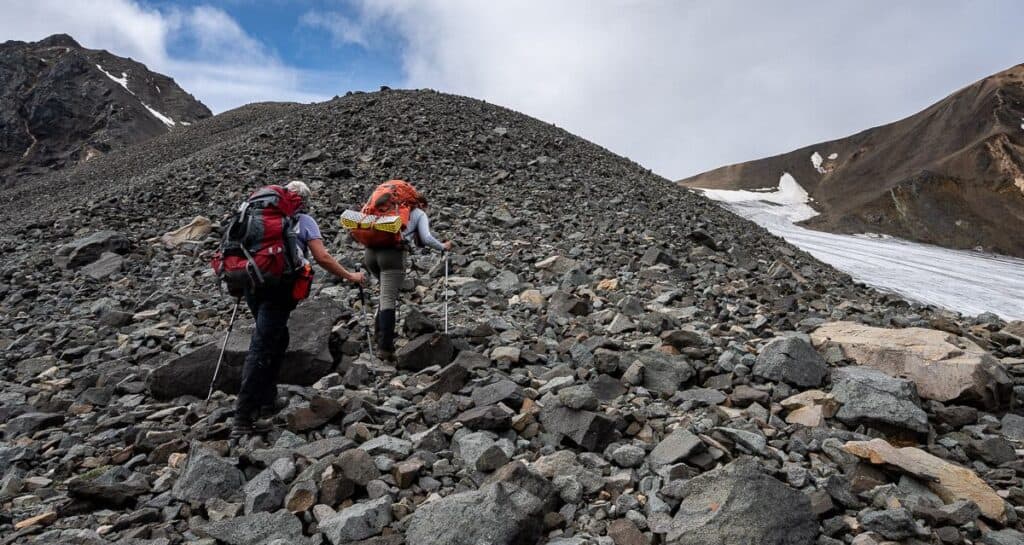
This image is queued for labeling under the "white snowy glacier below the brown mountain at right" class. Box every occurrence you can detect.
[698,174,1024,320]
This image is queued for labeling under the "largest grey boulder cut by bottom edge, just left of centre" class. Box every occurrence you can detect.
[406,462,556,545]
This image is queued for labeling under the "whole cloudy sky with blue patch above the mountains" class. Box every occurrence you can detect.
[0,0,1024,178]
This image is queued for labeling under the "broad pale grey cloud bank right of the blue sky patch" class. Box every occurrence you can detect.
[342,0,1021,178]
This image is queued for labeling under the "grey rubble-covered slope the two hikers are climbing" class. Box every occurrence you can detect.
[0,89,1024,545]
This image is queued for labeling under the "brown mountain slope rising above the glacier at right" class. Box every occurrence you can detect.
[681,65,1024,257]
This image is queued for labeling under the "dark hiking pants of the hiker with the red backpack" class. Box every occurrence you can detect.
[234,286,295,420]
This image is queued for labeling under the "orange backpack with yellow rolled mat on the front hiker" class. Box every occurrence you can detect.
[341,179,420,248]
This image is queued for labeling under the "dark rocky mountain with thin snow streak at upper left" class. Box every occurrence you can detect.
[0,35,211,182]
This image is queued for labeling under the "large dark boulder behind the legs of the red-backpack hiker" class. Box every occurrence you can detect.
[148,298,342,400]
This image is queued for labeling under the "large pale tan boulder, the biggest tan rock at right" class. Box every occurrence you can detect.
[811,322,1013,408]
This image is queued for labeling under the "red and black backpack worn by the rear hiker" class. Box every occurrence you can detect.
[210,185,304,297]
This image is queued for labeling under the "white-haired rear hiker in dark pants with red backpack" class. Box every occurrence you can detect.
[213,180,366,436]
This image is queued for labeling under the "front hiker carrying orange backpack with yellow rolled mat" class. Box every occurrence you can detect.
[342,180,452,361]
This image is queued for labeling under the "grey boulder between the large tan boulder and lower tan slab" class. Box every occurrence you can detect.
[831,367,928,433]
